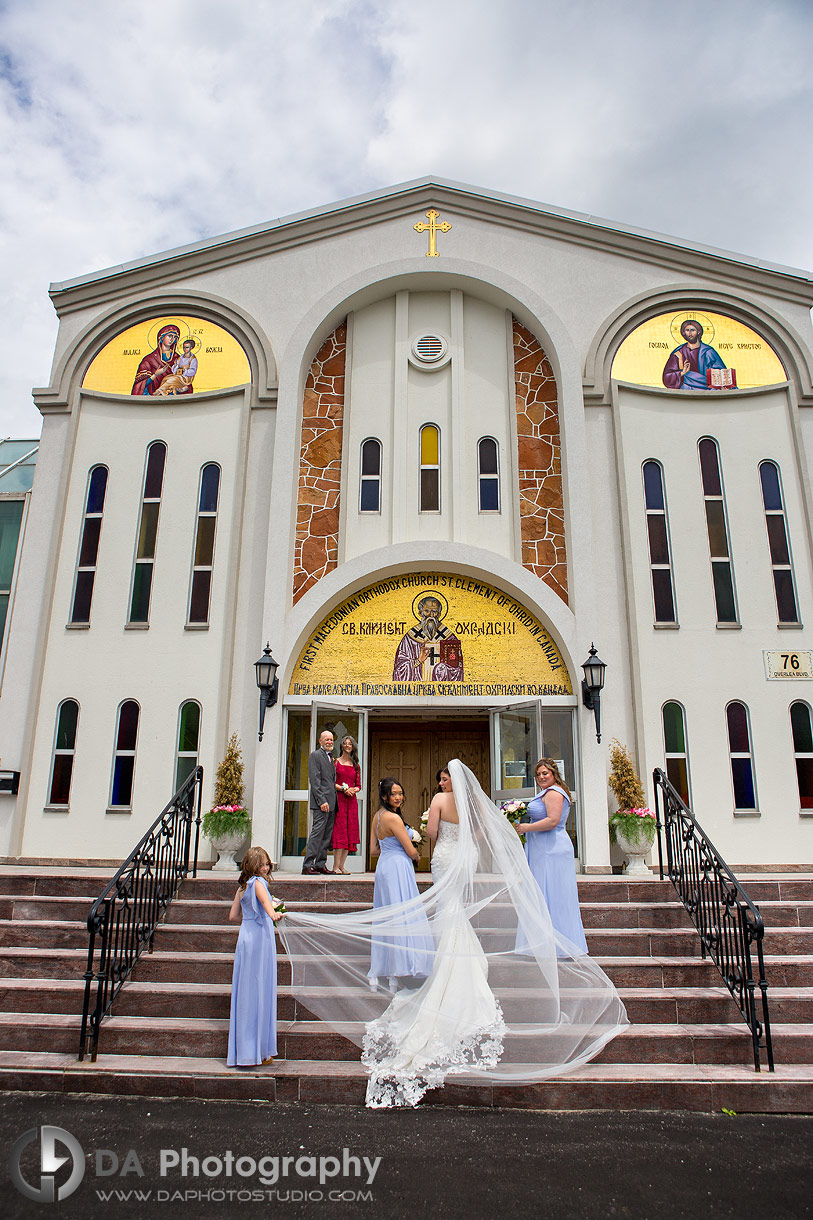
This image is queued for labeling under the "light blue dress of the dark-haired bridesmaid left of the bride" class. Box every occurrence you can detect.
[367,827,435,986]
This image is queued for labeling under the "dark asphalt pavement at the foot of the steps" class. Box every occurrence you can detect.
[0,1093,813,1220]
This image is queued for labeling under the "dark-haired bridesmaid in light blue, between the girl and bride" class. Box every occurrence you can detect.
[367,776,435,992]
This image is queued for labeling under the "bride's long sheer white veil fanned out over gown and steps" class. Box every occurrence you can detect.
[280,759,629,1107]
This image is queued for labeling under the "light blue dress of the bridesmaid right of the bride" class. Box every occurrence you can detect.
[518,784,587,956]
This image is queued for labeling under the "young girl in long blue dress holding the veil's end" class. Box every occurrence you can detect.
[226,847,282,1068]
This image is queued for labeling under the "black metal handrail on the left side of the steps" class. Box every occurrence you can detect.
[79,766,203,1061]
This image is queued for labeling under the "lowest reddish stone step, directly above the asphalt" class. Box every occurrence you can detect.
[0,1050,813,1121]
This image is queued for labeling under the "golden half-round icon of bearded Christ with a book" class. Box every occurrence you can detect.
[613,310,787,390]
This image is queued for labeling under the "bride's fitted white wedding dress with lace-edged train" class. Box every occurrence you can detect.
[361,822,505,1109]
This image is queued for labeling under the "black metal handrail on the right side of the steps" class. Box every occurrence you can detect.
[652,767,774,1071]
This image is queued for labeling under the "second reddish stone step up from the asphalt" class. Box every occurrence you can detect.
[0,1013,795,1064]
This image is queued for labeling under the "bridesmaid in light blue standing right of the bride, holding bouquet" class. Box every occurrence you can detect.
[515,759,587,956]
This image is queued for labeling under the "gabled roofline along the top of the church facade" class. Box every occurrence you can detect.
[49,177,813,315]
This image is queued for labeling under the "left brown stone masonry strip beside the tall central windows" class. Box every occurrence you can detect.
[293,322,347,605]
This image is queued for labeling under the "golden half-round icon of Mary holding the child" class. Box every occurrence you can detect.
[82,314,251,399]
